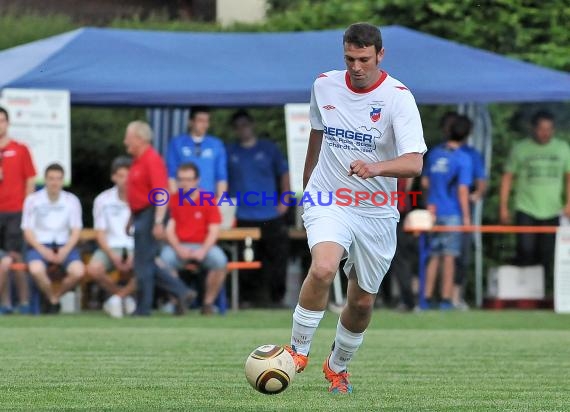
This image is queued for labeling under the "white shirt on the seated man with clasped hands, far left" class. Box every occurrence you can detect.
[21,188,83,245]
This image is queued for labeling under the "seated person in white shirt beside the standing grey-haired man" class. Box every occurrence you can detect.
[87,156,136,318]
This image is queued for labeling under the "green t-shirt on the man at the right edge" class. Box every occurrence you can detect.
[505,139,570,219]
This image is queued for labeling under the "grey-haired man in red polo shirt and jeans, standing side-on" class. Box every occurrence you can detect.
[124,121,196,316]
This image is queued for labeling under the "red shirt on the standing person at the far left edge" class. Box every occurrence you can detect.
[0,140,36,212]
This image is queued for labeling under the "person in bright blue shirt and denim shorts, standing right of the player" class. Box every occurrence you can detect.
[422,118,472,310]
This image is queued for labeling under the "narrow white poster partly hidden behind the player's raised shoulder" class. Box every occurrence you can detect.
[285,104,311,193]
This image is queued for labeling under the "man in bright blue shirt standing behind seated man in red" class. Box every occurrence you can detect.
[166,106,228,198]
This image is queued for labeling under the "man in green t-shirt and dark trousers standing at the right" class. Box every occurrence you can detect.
[500,111,570,283]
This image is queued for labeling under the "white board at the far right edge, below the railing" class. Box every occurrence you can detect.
[554,226,570,313]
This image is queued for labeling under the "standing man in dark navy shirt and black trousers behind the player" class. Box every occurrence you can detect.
[227,110,290,307]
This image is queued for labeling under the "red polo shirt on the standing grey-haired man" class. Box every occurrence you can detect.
[127,146,168,212]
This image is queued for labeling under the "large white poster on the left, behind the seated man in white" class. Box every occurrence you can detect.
[0,89,71,185]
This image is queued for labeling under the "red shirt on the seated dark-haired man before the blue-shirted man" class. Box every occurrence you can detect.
[170,193,222,243]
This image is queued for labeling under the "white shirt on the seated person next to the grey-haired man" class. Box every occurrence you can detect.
[93,186,134,250]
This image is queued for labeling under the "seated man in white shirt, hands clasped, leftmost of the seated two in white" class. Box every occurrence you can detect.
[21,163,85,313]
